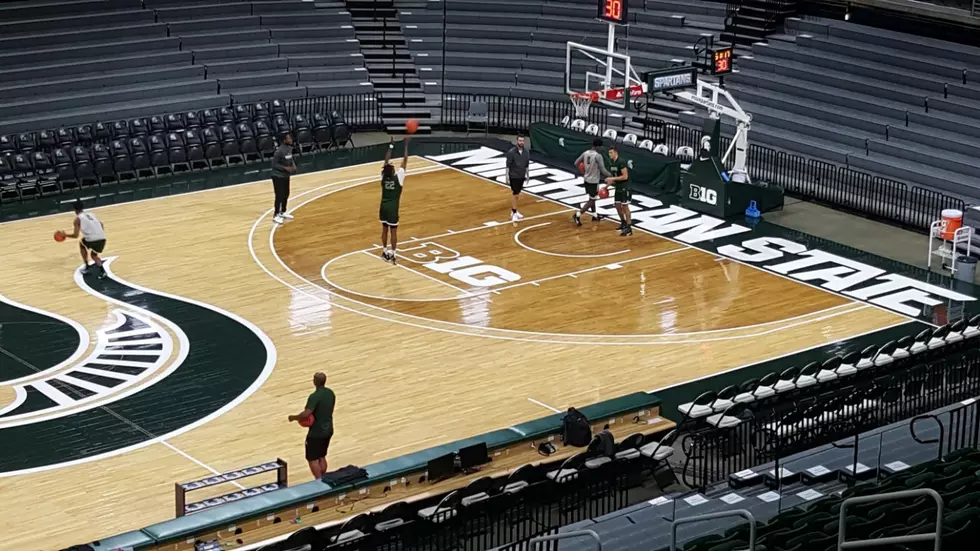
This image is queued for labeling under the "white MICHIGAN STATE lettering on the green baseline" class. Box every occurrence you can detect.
[429,147,975,320]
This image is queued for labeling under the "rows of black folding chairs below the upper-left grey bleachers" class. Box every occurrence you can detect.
[0,100,351,203]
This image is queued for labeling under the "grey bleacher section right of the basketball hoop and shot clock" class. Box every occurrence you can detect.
[684,19,980,203]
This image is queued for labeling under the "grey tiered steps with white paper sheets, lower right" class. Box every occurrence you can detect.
[512,398,980,551]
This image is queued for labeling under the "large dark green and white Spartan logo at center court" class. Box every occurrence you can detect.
[0,259,276,477]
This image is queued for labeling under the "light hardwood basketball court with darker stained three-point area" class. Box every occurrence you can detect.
[0,144,928,549]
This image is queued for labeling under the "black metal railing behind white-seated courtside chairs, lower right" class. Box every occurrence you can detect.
[681,350,980,488]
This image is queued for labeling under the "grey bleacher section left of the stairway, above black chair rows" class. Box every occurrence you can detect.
[0,0,371,134]
